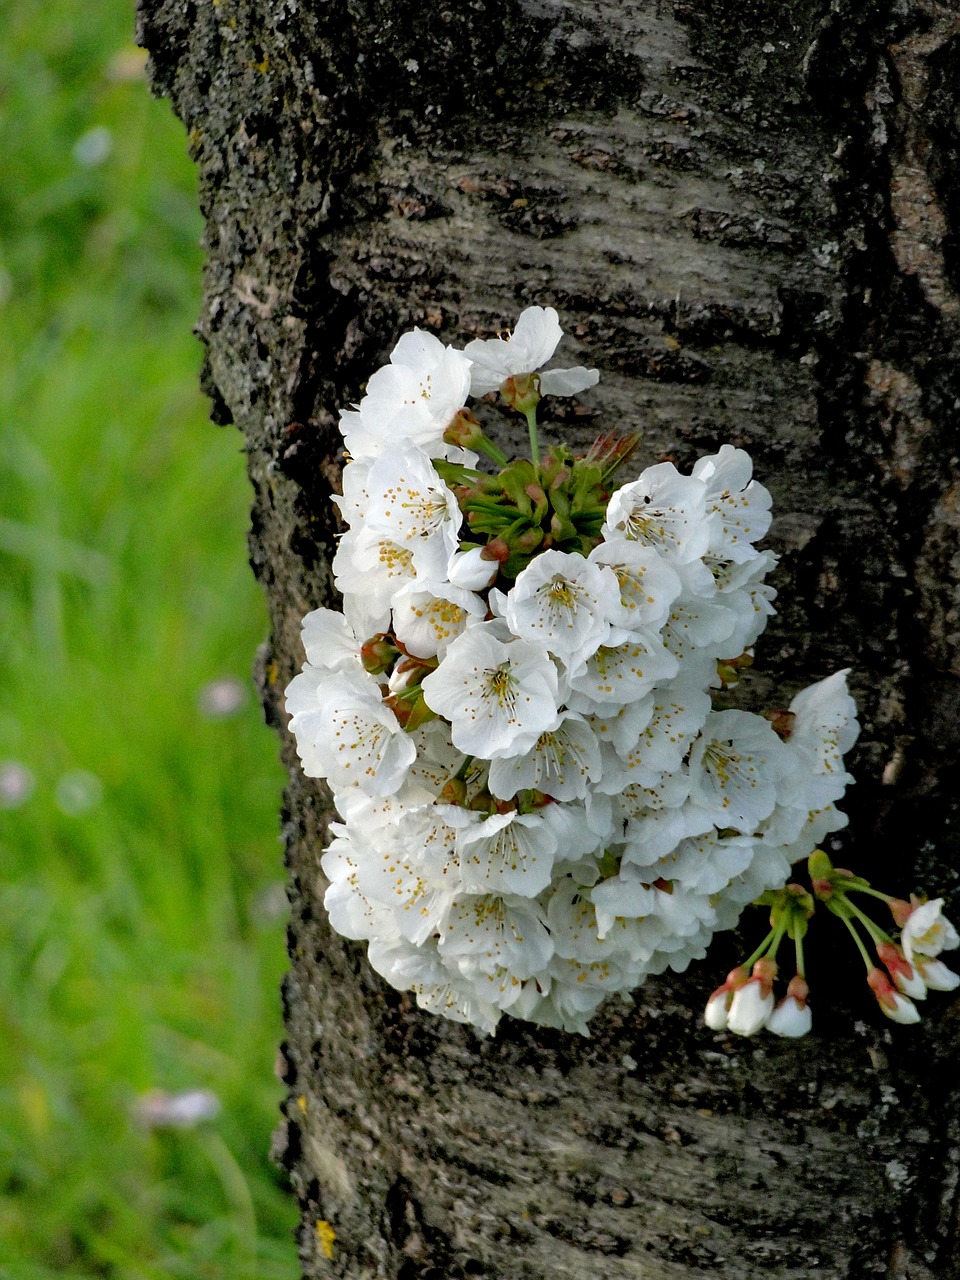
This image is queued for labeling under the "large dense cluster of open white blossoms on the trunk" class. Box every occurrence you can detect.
[287,307,858,1033]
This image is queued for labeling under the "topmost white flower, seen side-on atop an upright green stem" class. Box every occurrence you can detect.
[463,307,600,396]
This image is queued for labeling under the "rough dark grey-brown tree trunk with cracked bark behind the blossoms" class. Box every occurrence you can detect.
[140,0,960,1280]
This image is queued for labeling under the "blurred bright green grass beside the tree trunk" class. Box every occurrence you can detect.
[0,0,298,1280]
